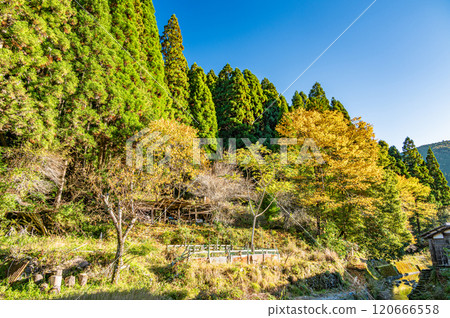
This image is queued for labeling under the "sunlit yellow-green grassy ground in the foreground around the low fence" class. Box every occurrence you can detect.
[0,225,372,299]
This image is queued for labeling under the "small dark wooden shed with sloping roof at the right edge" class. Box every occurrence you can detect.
[421,223,450,267]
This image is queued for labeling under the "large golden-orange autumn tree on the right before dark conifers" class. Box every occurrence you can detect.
[277,109,382,232]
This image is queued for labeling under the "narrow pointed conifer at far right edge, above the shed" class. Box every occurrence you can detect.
[427,147,450,206]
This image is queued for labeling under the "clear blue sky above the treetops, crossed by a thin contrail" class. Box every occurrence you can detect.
[153,0,450,147]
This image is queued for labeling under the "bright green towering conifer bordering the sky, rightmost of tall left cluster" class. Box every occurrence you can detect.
[106,0,167,143]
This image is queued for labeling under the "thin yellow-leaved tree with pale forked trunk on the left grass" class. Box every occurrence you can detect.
[85,119,202,283]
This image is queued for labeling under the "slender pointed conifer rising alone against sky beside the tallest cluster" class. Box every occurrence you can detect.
[161,15,192,124]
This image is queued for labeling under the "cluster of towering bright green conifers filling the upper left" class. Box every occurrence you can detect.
[0,0,167,163]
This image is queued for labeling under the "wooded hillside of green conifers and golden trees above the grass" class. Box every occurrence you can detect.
[0,0,450,298]
